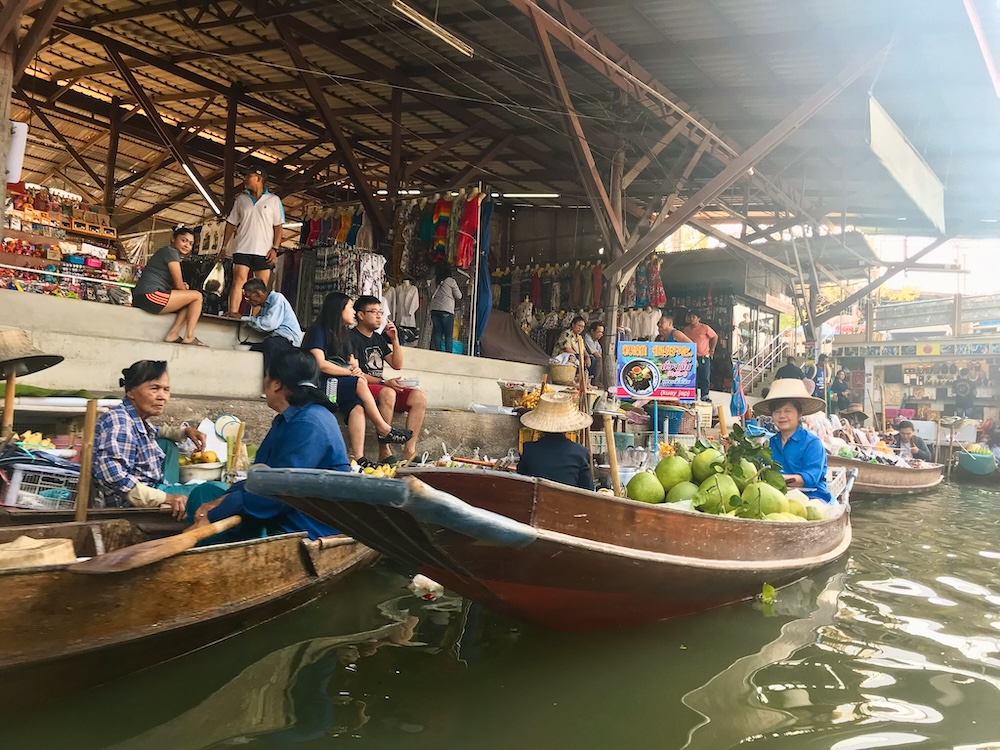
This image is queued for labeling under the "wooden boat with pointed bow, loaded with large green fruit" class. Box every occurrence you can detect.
[248,468,851,631]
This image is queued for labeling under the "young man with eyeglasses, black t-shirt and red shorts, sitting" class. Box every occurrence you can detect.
[350,295,427,461]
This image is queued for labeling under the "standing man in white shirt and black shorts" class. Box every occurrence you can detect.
[219,167,285,318]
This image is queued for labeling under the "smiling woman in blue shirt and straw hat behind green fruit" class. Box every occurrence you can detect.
[753,378,833,503]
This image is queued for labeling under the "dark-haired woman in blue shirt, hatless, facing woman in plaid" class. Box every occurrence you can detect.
[187,349,351,544]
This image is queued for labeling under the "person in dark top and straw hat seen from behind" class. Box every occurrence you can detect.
[517,393,594,490]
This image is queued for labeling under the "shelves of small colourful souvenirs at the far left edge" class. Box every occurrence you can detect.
[0,183,135,305]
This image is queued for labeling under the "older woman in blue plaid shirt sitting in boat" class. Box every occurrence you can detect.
[93,360,215,516]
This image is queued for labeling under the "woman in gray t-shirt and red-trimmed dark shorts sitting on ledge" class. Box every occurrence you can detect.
[132,226,205,346]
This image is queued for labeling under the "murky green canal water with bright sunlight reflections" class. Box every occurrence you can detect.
[0,486,1000,750]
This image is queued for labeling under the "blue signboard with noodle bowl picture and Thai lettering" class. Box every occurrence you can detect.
[615,341,698,401]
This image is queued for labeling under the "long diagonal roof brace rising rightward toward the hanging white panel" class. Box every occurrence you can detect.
[604,48,885,279]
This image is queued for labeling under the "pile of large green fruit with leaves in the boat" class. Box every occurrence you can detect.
[625,425,833,522]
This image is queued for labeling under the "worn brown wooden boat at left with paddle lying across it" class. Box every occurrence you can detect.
[0,519,377,705]
